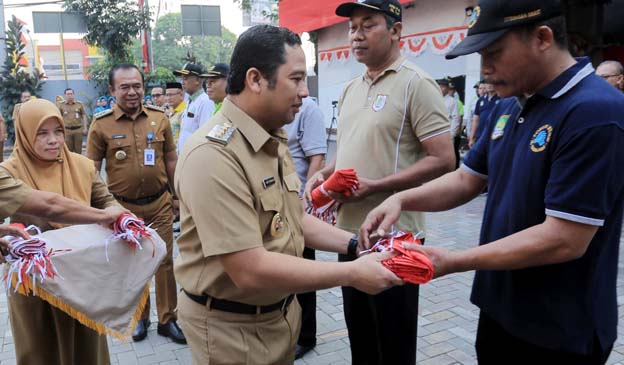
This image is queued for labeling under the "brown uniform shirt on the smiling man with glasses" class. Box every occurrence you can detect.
[87,106,175,199]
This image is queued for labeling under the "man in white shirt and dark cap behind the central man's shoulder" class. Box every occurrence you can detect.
[173,63,215,153]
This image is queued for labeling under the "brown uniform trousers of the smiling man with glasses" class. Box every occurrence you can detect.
[119,192,178,324]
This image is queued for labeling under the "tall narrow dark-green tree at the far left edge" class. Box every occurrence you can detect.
[0,15,43,139]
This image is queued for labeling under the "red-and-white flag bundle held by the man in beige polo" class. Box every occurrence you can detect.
[306,169,360,225]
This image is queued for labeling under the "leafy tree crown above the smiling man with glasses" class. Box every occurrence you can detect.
[65,0,150,61]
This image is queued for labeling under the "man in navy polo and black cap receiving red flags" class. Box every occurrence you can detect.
[360,0,624,365]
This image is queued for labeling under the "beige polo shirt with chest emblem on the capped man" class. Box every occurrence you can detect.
[336,57,450,232]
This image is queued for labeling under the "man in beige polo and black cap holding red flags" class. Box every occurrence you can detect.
[306,0,455,365]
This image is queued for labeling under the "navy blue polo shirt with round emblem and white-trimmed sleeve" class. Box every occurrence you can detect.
[462,58,624,354]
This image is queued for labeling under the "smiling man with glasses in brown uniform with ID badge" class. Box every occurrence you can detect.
[87,65,186,343]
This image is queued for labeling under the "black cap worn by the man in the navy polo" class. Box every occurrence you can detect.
[446,0,563,59]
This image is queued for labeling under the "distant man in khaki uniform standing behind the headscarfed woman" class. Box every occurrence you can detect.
[58,88,87,153]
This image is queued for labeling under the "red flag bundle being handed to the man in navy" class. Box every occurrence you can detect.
[370,231,433,284]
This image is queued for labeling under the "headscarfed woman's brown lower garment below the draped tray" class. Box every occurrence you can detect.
[8,292,110,365]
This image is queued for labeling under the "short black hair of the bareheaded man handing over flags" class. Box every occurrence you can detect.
[227,25,301,95]
